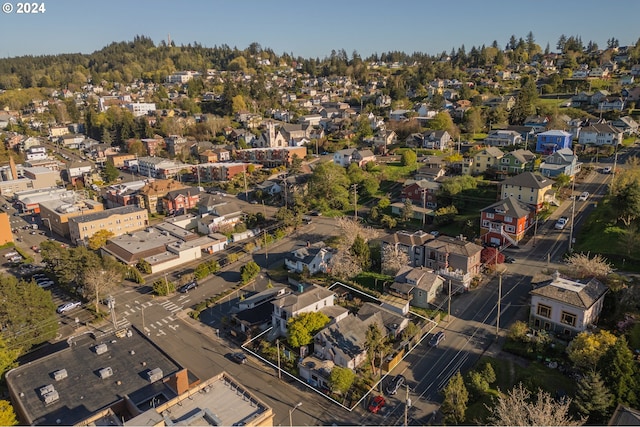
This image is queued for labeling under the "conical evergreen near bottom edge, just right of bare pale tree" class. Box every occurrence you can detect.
[574,370,613,425]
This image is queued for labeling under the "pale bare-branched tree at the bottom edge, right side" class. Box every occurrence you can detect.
[485,383,583,426]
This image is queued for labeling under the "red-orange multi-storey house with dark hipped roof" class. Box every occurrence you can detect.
[480,197,535,247]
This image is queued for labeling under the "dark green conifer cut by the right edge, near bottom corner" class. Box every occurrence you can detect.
[600,336,639,406]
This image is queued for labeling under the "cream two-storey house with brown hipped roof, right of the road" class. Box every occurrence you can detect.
[529,272,608,338]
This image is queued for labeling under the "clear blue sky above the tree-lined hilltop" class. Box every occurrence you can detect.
[0,0,640,59]
